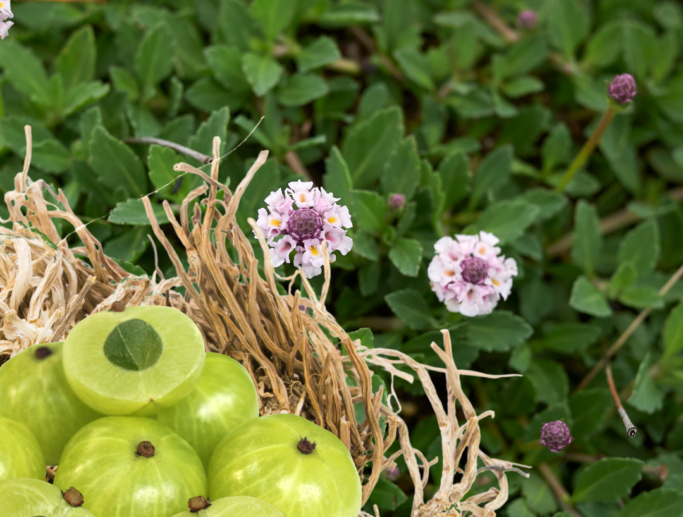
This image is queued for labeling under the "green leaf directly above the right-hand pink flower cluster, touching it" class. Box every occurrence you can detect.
[468,199,539,244]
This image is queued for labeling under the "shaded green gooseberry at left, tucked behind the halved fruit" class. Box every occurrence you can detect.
[0,343,102,465]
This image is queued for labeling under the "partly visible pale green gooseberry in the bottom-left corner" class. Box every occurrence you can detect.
[0,479,93,517]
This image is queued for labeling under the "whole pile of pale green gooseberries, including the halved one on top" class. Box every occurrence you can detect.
[0,302,361,517]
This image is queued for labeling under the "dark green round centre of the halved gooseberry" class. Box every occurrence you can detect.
[104,318,164,372]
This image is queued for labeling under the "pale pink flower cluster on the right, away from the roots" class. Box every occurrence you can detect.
[428,232,517,316]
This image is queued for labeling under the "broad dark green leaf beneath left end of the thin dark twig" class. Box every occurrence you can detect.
[89,127,147,197]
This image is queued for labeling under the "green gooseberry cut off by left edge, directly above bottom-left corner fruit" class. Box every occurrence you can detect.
[0,410,45,480]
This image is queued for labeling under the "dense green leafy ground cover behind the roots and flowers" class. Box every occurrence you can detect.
[0,0,683,517]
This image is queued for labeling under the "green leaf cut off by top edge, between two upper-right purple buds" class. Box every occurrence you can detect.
[544,0,590,59]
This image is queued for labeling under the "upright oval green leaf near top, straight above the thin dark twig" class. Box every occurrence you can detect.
[135,23,175,99]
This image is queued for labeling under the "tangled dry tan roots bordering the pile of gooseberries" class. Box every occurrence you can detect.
[0,126,526,517]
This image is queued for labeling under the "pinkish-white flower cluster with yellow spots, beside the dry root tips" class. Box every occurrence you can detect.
[257,180,353,278]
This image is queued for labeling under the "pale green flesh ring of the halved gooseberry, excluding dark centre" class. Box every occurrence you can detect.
[64,306,206,416]
